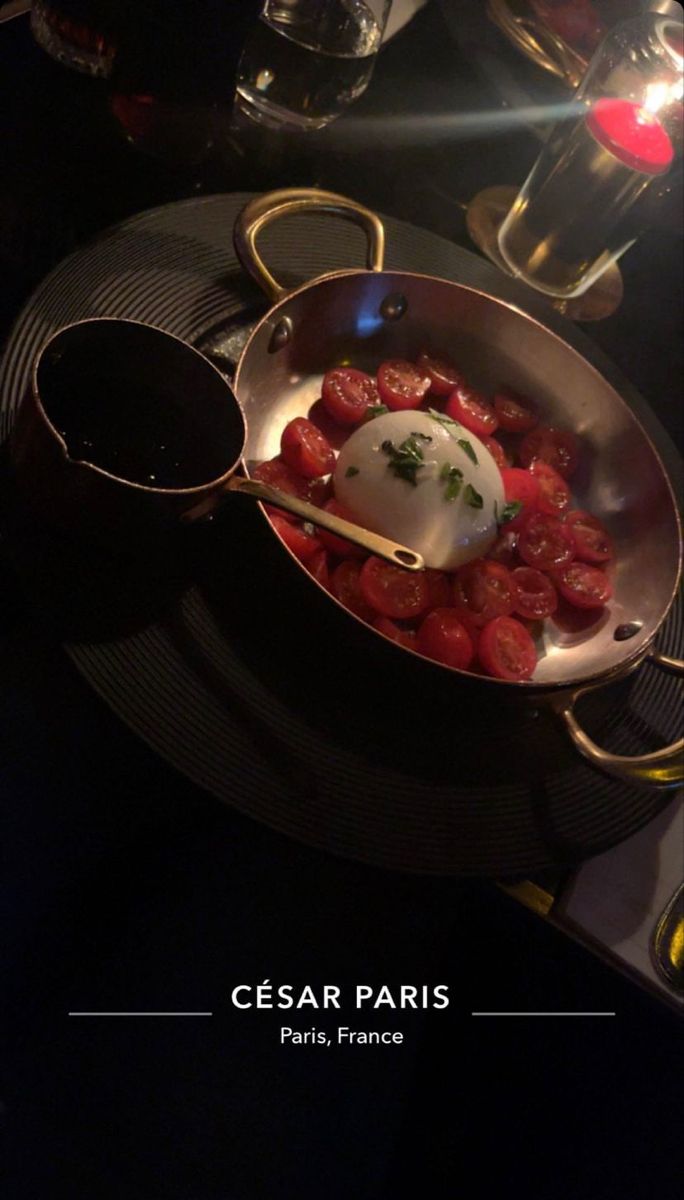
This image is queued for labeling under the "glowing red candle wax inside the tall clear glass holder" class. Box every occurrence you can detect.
[587,97,674,175]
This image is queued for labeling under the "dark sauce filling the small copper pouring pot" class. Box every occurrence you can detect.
[41,362,235,488]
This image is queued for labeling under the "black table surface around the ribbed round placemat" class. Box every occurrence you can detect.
[0,7,683,1200]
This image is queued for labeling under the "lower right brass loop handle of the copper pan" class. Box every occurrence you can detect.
[553,650,684,788]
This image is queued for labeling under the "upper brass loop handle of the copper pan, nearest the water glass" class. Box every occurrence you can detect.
[233,187,385,304]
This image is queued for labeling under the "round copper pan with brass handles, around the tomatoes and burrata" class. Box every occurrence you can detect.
[234,188,684,787]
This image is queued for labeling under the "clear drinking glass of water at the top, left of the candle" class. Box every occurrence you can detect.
[235,0,391,130]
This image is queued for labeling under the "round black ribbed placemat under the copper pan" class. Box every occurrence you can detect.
[0,194,684,876]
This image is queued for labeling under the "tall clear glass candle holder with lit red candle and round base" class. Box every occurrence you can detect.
[467,13,684,320]
